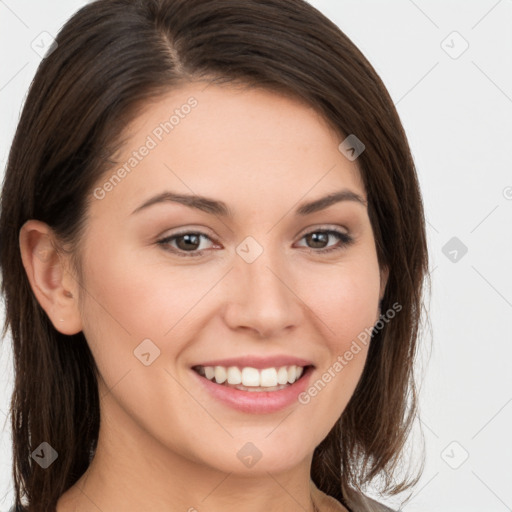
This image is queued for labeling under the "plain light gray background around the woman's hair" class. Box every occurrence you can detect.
[0,0,512,512]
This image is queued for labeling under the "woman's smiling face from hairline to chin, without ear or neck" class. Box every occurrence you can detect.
[72,84,385,474]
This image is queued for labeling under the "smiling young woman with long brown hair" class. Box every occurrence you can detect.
[0,0,427,512]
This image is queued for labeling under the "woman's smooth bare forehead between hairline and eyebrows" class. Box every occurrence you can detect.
[91,83,365,218]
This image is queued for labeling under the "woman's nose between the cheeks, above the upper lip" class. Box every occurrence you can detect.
[224,243,304,338]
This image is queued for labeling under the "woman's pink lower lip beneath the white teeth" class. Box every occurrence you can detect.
[192,366,314,414]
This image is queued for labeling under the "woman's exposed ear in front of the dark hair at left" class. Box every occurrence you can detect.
[19,220,82,335]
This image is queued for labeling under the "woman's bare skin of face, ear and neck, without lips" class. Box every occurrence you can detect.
[20,83,387,512]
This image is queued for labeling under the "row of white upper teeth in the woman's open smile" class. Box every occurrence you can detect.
[196,365,304,390]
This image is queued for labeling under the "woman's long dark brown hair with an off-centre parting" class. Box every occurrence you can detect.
[0,0,428,512]
